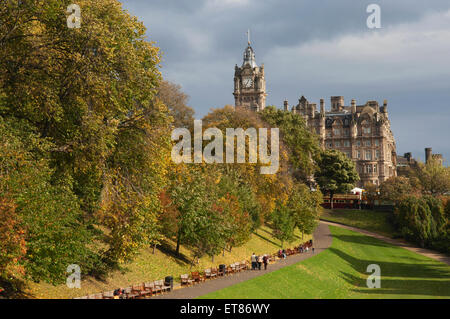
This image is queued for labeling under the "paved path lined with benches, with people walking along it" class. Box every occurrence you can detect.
[152,222,332,299]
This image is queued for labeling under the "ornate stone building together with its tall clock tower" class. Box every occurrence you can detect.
[233,39,397,187]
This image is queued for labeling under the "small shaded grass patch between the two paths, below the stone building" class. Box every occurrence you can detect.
[320,209,395,237]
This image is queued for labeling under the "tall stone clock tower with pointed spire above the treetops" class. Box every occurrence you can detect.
[233,33,267,112]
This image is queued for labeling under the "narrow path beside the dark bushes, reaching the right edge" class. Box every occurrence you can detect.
[320,221,450,265]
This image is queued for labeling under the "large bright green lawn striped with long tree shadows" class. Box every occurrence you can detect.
[202,226,450,299]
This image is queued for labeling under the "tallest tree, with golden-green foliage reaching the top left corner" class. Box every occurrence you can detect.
[0,0,171,281]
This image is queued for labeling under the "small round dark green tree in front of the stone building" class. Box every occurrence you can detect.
[315,150,359,209]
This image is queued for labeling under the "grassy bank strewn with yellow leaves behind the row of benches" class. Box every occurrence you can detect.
[26,226,311,299]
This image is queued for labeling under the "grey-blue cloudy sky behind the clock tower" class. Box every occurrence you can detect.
[121,0,450,165]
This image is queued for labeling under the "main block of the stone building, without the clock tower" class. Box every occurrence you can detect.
[284,96,397,187]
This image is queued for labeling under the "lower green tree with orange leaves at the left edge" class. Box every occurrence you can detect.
[0,116,95,283]
